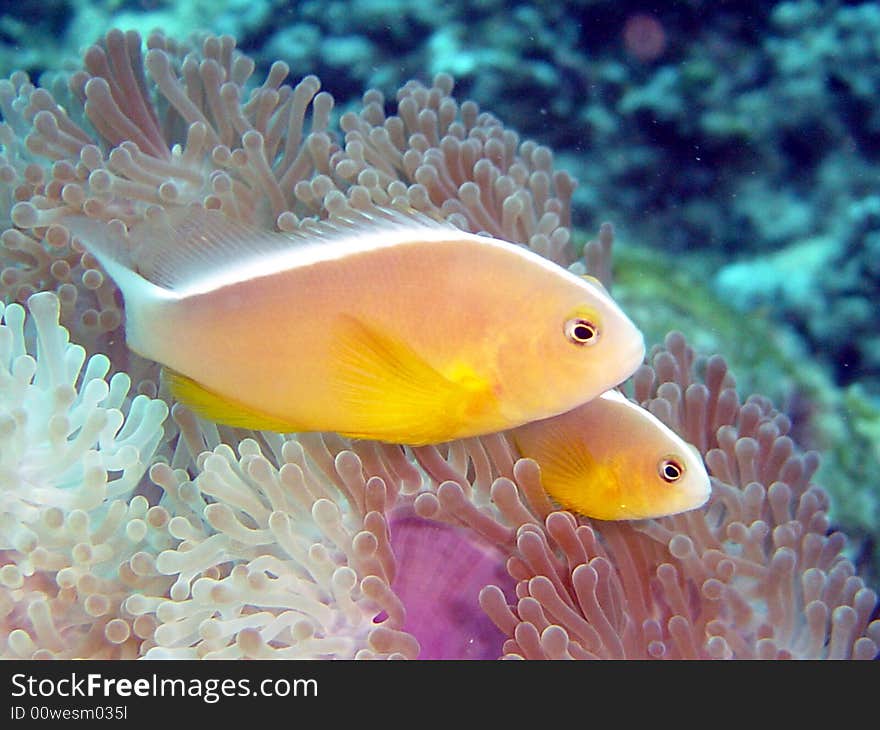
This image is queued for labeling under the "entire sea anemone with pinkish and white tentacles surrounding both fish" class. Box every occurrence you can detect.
[0,31,880,658]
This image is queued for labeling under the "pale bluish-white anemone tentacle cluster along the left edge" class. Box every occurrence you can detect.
[0,292,168,658]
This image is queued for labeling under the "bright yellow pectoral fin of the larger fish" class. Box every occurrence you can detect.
[334,316,495,445]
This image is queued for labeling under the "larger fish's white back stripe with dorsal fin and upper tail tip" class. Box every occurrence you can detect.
[72,206,615,307]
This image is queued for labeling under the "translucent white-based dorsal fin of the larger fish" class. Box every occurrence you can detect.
[129,206,470,295]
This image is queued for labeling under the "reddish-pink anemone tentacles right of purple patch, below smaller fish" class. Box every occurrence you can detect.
[481,333,880,659]
